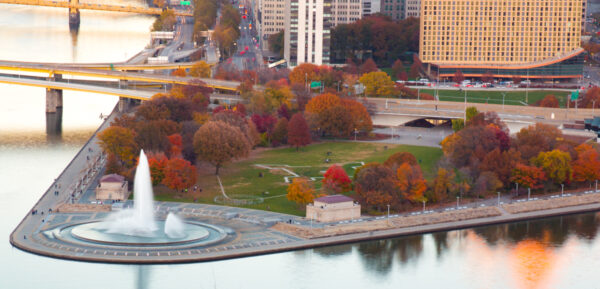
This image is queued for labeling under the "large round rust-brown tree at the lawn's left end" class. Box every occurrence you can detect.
[194,121,251,175]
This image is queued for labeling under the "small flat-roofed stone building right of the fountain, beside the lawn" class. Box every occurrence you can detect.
[306,195,360,222]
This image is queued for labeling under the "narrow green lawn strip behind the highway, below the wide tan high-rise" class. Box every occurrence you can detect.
[420,89,569,107]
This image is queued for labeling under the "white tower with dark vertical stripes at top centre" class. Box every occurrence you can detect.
[284,0,331,67]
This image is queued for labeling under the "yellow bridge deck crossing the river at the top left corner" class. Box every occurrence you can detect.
[0,0,194,17]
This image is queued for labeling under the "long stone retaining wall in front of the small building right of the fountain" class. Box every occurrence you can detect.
[272,207,502,239]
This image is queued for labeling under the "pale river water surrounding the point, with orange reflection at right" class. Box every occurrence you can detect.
[0,5,600,289]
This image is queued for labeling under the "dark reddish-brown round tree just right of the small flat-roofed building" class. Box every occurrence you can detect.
[354,163,397,210]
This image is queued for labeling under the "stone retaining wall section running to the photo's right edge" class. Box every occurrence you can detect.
[502,194,600,214]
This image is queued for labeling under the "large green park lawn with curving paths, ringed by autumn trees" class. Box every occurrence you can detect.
[155,142,442,215]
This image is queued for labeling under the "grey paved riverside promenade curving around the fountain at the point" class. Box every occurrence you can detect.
[10,105,600,264]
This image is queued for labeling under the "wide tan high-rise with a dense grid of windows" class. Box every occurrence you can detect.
[419,0,585,79]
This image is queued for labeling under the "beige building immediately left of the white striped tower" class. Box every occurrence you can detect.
[254,0,285,50]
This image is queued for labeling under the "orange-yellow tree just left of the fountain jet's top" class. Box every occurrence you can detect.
[98,126,138,167]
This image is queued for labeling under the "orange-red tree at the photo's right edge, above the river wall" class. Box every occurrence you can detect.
[572,144,600,183]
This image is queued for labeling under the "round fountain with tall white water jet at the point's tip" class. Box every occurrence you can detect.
[57,150,226,247]
